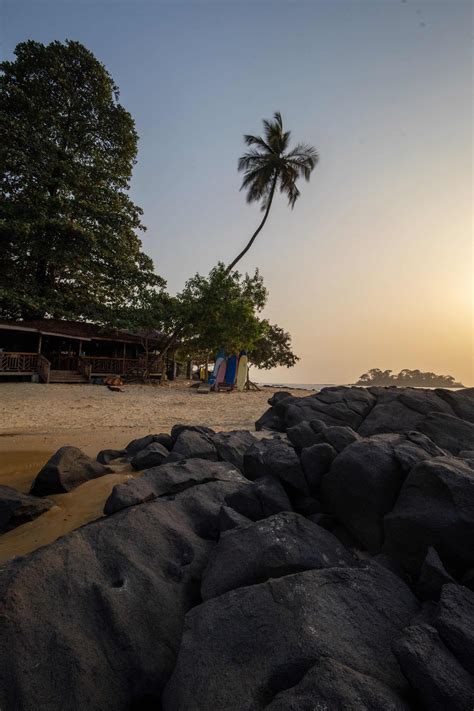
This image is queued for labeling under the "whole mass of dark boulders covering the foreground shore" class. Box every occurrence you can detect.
[0,387,474,711]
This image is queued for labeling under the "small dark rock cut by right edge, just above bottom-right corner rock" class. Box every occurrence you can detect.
[433,583,474,674]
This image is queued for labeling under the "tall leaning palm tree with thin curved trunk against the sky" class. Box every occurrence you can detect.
[227,111,319,272]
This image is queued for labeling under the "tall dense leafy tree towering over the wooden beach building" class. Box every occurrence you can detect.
[0,41,163,320]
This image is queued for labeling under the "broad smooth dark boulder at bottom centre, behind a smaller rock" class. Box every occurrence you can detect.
[162,565,418,711]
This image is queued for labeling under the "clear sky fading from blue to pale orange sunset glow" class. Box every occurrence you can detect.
[0,0,474,386]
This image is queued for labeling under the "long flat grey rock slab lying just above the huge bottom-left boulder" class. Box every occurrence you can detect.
[104,458,247,516]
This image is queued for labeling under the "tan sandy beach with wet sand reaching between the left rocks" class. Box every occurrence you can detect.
[0,382,308,562]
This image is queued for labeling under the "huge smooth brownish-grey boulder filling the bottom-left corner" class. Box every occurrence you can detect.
[0,487,211,711]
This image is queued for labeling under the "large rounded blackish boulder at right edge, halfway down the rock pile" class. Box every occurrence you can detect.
[384,455,474,573]
